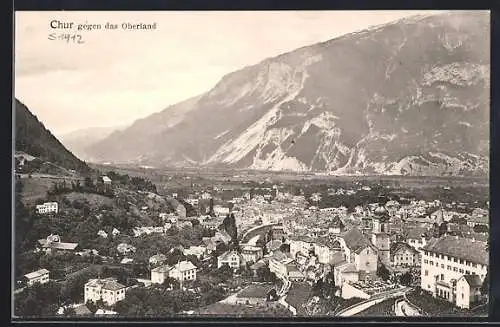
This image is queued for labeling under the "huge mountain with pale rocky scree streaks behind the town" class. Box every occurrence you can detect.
[87,12,490,175]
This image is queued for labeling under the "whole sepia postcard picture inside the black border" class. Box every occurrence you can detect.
[11,10,491,321]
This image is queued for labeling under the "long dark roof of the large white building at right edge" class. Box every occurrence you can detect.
[422,235,489,265]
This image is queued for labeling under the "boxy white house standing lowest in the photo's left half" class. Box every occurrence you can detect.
[84,278,126,305]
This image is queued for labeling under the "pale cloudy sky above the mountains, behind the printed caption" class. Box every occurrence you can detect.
[15,11,446,135]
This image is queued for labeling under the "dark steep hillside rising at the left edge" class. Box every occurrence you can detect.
[14,99,90,173]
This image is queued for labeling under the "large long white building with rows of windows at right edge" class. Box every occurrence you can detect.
[421,236,489,307]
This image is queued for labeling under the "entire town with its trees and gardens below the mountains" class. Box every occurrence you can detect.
[14,170,489,317]
